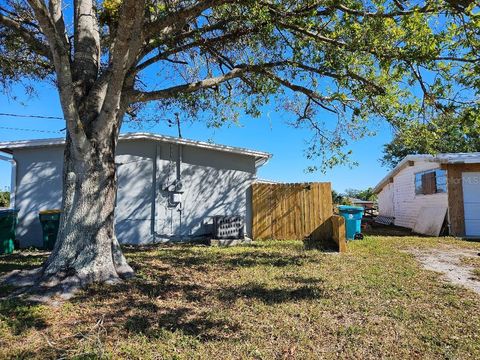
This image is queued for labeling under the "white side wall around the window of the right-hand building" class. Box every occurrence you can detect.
[378,161,448,229]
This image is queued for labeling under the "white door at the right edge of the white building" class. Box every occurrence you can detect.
[462,172,480,236]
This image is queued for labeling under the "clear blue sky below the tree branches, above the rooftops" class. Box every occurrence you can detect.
[0,85,392,191]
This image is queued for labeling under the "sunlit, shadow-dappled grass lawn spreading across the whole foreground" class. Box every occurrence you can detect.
[0,236,480,359]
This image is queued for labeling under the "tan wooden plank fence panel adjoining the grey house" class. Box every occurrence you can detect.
[252,183,333,240]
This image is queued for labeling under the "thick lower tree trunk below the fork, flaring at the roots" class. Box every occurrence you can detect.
[40,131,133,287]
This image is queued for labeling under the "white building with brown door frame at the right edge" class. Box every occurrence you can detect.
[374,152,480,237]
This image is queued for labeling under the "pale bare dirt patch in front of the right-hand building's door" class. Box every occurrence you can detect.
[409,247,480,294]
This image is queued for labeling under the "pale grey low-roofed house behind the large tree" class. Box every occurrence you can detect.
[0,133,270,247]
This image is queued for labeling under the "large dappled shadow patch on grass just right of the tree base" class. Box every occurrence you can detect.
[72,279,241,342]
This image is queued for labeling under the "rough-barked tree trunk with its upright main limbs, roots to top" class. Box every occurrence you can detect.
[24,0,145,294]
